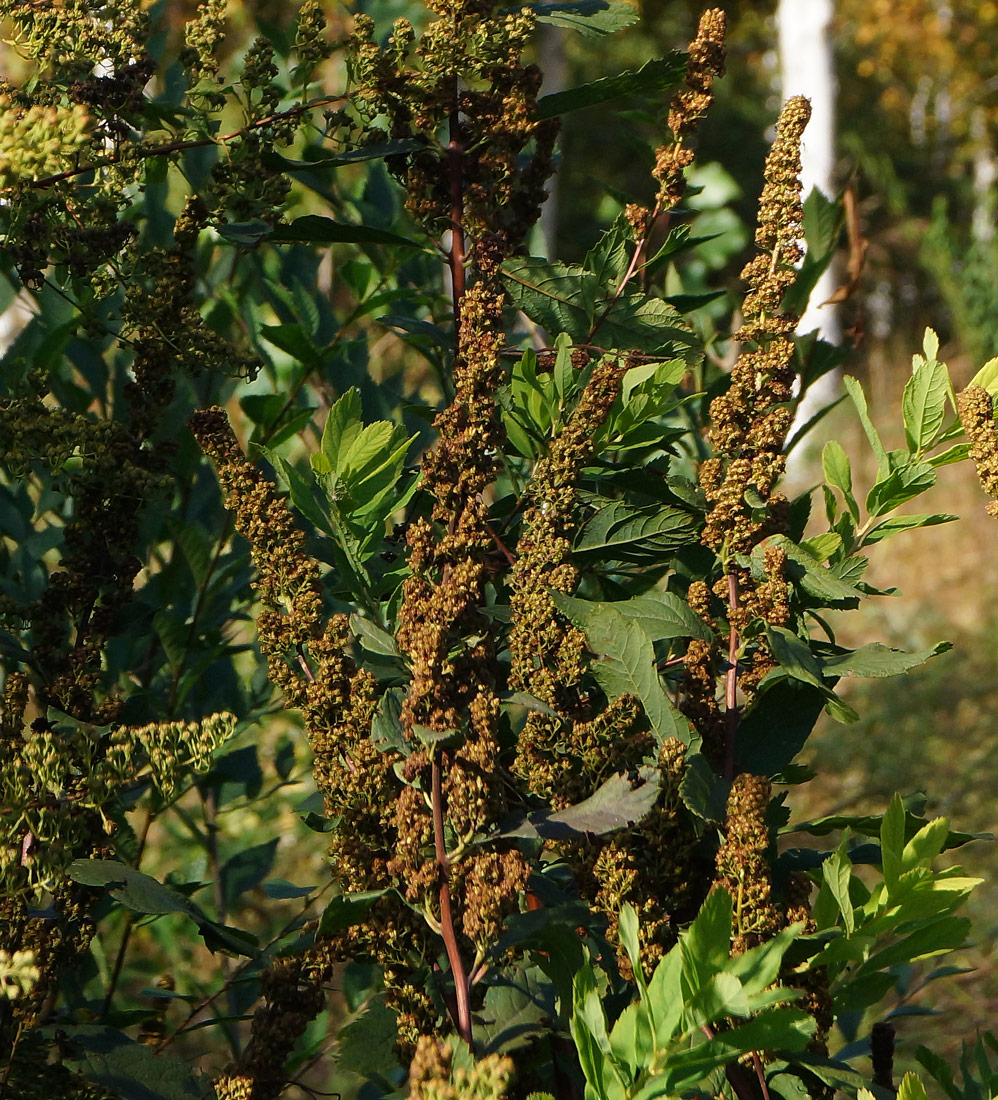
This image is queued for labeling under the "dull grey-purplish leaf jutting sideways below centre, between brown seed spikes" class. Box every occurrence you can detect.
[495,768,659,840]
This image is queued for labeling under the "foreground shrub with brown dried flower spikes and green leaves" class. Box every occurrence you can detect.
[0,0,998,1100]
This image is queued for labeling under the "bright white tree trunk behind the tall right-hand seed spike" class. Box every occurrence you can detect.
[777,0,842,475]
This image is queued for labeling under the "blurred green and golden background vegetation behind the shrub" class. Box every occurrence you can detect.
[0,0,998,1091]
